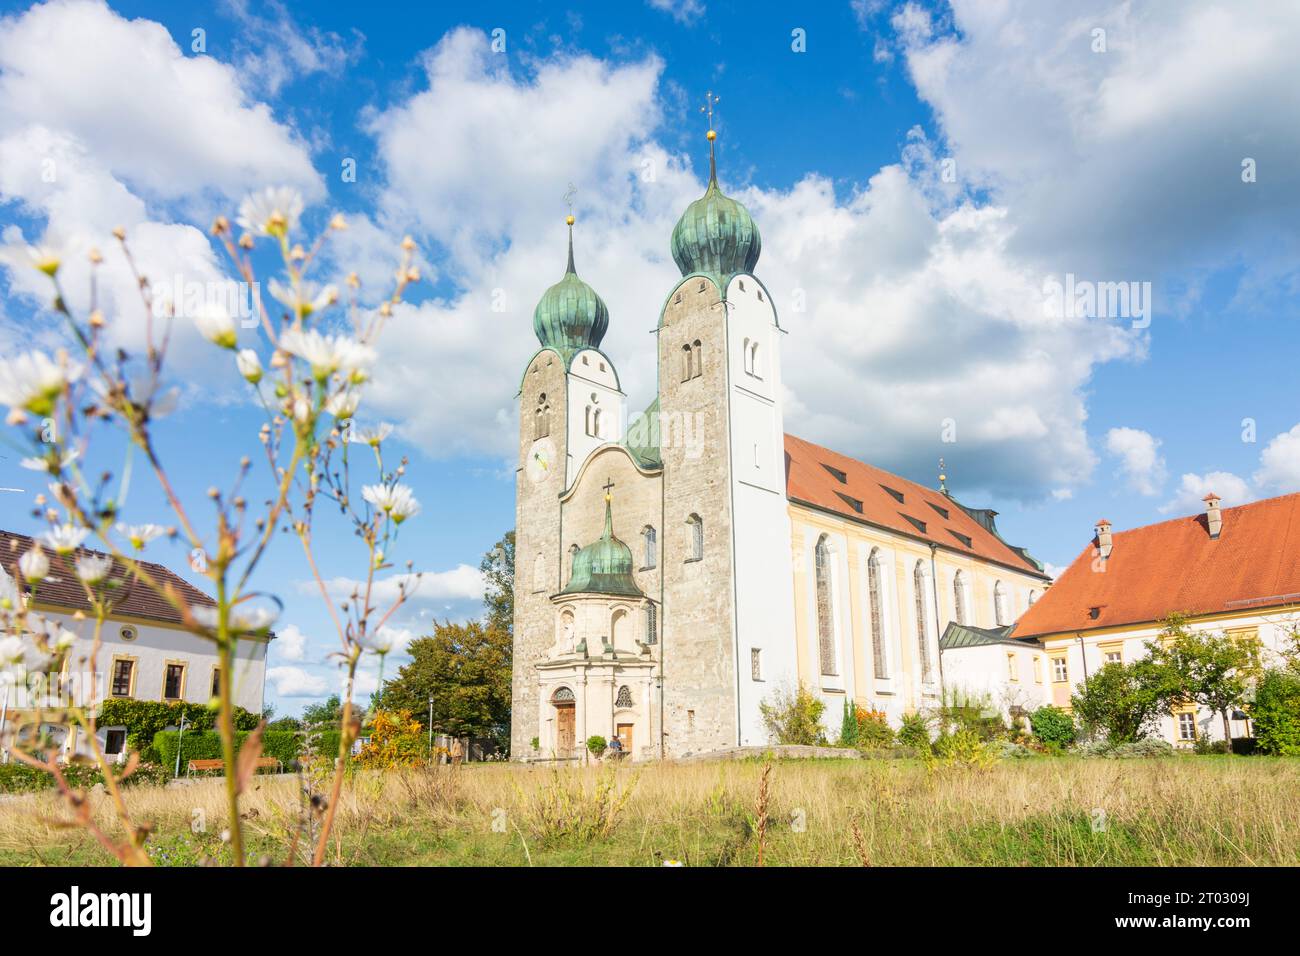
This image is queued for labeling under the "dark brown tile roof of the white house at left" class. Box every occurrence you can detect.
[0,531,216,624]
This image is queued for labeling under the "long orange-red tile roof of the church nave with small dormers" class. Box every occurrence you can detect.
[785,434,1047,579]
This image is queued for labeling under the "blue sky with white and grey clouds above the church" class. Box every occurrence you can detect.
[0,0,1300,713]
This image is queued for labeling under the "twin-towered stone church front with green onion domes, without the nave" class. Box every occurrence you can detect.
[511,117,797,760]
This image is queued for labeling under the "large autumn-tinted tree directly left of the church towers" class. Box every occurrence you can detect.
[384,620,511,740]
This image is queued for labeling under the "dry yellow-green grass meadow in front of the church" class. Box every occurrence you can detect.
[0,757,1300,866]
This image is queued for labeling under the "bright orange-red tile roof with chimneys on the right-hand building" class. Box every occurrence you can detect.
[1013,494,1300,637]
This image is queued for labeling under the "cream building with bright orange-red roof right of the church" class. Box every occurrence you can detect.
[985,494,1300,745]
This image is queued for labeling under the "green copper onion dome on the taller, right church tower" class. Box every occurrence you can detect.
[672,139,763,283]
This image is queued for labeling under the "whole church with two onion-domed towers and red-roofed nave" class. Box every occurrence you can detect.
[511,117,1049,760]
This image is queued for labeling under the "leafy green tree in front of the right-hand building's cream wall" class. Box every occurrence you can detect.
[1147,615,1260,743]
